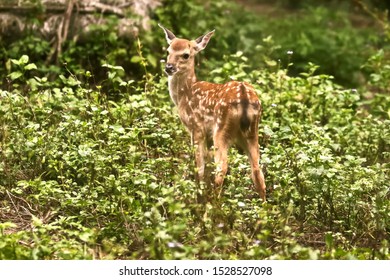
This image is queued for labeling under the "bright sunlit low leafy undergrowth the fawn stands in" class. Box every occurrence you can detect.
[0,50,390,259]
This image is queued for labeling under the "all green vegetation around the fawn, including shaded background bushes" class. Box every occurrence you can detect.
[0,1,390,259]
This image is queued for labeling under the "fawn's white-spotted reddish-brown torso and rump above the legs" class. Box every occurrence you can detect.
[181,81,261,139]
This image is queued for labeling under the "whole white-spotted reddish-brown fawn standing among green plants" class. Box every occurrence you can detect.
[159,25,265,201]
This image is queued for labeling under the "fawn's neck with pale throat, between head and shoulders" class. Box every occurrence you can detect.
[168,70,196,106]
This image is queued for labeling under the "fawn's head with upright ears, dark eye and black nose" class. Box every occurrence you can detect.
[159,24,214,76]
